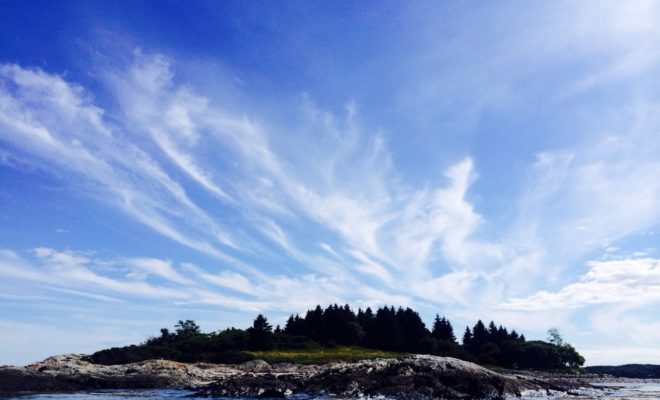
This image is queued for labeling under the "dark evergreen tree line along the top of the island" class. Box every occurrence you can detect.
[89,304,584,369]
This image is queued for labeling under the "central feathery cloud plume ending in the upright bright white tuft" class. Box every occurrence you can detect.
[105,51,499,304]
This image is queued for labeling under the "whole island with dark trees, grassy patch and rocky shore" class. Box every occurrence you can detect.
[0,305,596,399]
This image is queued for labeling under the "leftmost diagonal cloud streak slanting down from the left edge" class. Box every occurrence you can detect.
[0,65,242,262]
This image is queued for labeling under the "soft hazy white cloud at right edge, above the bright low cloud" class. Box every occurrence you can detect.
[502,99,660,297]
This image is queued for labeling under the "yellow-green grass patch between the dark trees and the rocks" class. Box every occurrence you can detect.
[246,346,404,364]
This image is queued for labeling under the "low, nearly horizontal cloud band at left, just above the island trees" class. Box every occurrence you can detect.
[0,248,348,311]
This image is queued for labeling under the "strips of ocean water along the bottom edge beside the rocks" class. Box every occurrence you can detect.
[0,382,660,400]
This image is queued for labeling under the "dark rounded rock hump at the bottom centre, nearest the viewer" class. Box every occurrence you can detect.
[199,355,519,399]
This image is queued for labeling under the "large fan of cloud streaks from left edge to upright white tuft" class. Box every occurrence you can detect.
[2,51,497,316]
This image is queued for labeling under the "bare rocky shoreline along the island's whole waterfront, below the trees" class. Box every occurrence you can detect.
[0,355,591,399]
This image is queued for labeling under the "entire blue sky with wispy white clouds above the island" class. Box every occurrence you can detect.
[0,1,660,364]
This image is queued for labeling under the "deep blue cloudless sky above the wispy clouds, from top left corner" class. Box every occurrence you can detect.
[0,1,490,175]
